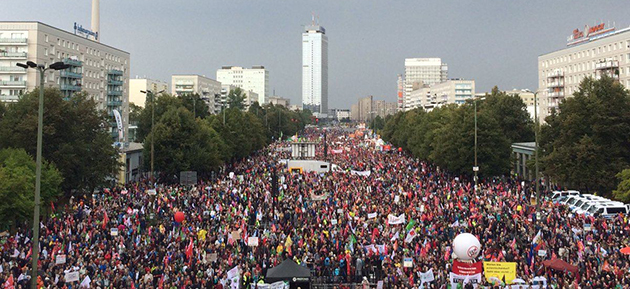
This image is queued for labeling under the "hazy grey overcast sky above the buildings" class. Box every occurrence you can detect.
[0,0,630,108]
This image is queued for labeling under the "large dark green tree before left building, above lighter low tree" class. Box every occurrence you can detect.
[0,88,119,192]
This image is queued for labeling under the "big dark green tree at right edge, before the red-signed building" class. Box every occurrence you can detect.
[541,77,630,195]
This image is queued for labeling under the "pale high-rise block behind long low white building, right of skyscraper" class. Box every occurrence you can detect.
[403,58,448,110]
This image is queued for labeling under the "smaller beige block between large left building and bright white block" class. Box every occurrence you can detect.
[171,74,221,113]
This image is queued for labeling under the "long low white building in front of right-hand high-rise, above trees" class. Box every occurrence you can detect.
[406,79,475,111]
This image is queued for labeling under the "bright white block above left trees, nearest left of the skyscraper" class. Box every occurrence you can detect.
[217,65,269,105]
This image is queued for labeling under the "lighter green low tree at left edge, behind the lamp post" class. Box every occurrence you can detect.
[0,148,63,225]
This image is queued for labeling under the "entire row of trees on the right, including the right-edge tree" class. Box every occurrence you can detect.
[375,75,630,202]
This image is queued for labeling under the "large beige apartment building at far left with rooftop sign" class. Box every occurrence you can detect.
[0,22,130,141]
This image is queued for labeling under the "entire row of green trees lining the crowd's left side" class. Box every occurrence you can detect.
[0,88,312,225]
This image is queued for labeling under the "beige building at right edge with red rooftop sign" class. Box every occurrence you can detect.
[538,23,630,122]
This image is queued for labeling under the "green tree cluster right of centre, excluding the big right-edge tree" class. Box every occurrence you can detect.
[382,88,533,176]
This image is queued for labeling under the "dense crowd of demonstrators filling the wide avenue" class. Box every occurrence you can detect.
[0,129,630,288]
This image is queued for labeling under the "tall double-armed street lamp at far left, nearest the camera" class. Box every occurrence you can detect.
[16,61,70,289]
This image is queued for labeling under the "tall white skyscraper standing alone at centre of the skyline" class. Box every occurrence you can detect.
[302,19,328,114]
